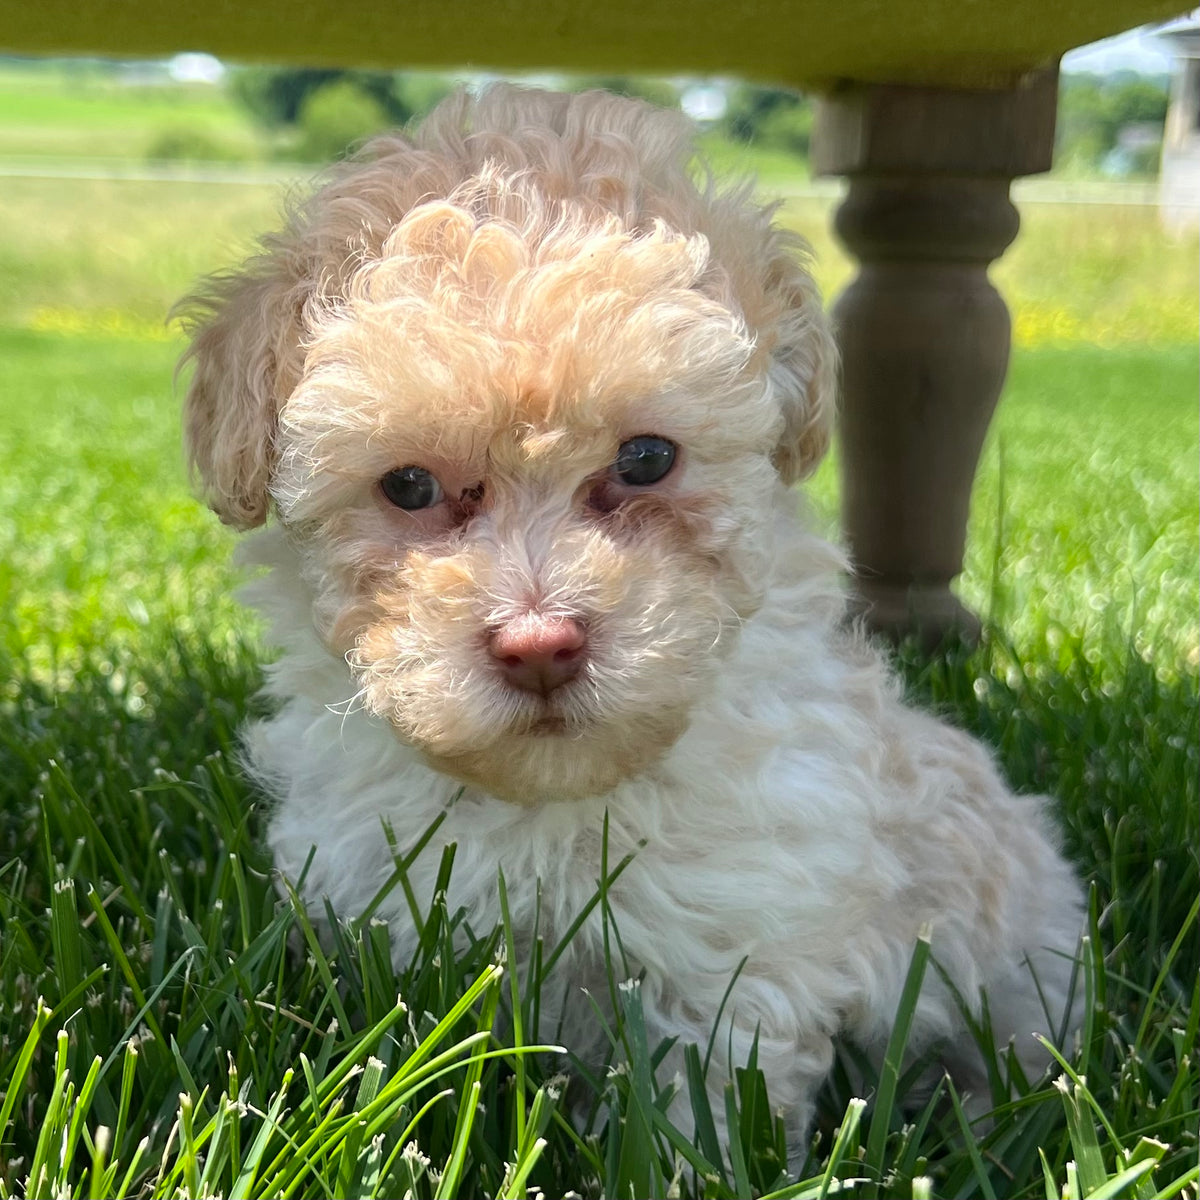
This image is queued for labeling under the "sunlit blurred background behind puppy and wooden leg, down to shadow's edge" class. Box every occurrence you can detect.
[0,32,1200,679]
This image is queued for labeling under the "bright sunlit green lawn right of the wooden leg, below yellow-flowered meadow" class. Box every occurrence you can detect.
[961,346,1200,677]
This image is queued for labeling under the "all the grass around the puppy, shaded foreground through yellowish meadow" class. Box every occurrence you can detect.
[0,97,1200,1198]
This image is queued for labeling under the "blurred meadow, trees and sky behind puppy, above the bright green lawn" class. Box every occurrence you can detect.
[0,34,1200,343]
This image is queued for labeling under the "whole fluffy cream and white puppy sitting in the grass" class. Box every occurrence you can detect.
[186,86,1081,1135]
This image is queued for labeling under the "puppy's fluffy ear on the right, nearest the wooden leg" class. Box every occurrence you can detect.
[766,229,838,484]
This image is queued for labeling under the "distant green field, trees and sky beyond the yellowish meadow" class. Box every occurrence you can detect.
[0,34,1174,181]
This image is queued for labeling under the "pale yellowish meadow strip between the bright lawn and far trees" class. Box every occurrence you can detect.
[0,154,1200,347]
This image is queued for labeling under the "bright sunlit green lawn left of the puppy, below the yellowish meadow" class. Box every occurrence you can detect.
[0,334,246,684]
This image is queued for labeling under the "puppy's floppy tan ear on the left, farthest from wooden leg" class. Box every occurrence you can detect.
[176,256,307,529]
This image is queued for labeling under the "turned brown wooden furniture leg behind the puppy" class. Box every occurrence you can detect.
[814,74,1056,643]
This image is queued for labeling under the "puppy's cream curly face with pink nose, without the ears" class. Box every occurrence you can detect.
[180,88,835,803]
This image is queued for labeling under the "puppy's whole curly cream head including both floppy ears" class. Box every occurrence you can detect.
[187,88,834,802]
